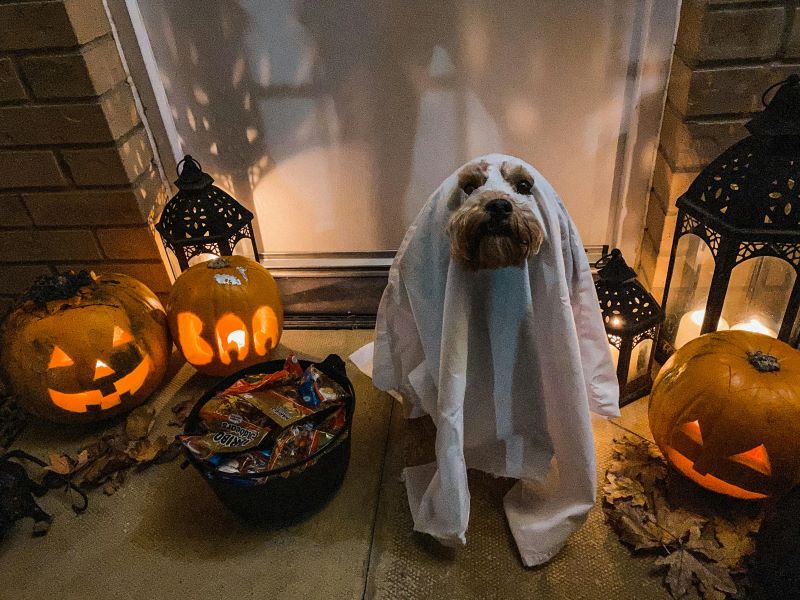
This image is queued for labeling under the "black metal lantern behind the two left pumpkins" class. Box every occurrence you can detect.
[156,154,258,271]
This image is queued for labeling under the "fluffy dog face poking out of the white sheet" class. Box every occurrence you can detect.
[447,161,543,270]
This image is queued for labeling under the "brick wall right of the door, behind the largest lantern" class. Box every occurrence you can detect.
[638,0,800,297]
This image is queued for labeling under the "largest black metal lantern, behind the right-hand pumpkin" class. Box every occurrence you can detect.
[658,75,800,360]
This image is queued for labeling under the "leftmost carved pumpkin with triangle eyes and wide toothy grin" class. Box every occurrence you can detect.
[1,271,171,423]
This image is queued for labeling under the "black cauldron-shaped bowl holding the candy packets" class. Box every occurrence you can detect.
[184,354,355,524]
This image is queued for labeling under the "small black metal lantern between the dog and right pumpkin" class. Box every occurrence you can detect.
[595,248,664,405]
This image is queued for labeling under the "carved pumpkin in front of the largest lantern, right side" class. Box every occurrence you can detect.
[649,331,800,500]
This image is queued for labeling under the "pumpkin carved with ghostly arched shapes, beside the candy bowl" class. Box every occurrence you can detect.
[167,256,283,375]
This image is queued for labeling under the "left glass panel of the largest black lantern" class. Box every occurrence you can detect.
[663,233,727,349]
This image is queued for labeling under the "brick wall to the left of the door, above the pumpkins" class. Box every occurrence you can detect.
[0,0,169,315]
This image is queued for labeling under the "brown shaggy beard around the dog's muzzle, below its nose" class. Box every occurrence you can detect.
[448,202,543,270]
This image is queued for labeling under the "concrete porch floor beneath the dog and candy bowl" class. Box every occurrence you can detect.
[0,330,669,600]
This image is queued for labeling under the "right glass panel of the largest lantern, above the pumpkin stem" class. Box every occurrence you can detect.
[722,256,797,337]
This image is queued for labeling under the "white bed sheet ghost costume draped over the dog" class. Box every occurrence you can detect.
[362,154,619,566]
